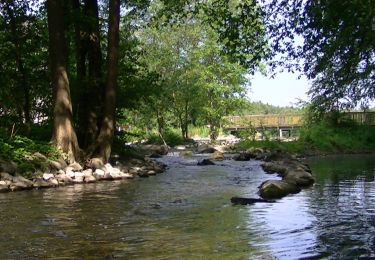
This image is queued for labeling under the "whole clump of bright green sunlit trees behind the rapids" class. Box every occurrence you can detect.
[141,13,250,140]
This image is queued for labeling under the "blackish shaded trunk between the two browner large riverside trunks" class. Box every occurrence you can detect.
[72,0,104,148]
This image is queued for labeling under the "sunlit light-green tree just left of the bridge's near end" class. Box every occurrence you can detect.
[195,30,247,140]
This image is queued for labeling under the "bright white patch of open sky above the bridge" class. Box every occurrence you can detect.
[248,72,309,106]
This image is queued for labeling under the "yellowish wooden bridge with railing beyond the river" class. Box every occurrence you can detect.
[224,112,375,138]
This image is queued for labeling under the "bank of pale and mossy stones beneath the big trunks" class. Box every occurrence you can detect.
[0,146,166,192]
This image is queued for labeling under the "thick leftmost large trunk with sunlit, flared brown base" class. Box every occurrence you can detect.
[47,0,79,162]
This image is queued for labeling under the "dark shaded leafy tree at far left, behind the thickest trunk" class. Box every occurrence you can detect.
[0,1,51,135]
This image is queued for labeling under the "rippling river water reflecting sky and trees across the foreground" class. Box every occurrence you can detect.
[0,155,375,259]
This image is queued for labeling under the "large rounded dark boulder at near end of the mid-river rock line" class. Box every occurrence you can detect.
[259,180,301,199]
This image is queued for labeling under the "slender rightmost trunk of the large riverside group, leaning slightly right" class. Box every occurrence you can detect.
[96,0,120,161]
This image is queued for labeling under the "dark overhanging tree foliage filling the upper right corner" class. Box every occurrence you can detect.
[265,0,375,112]
